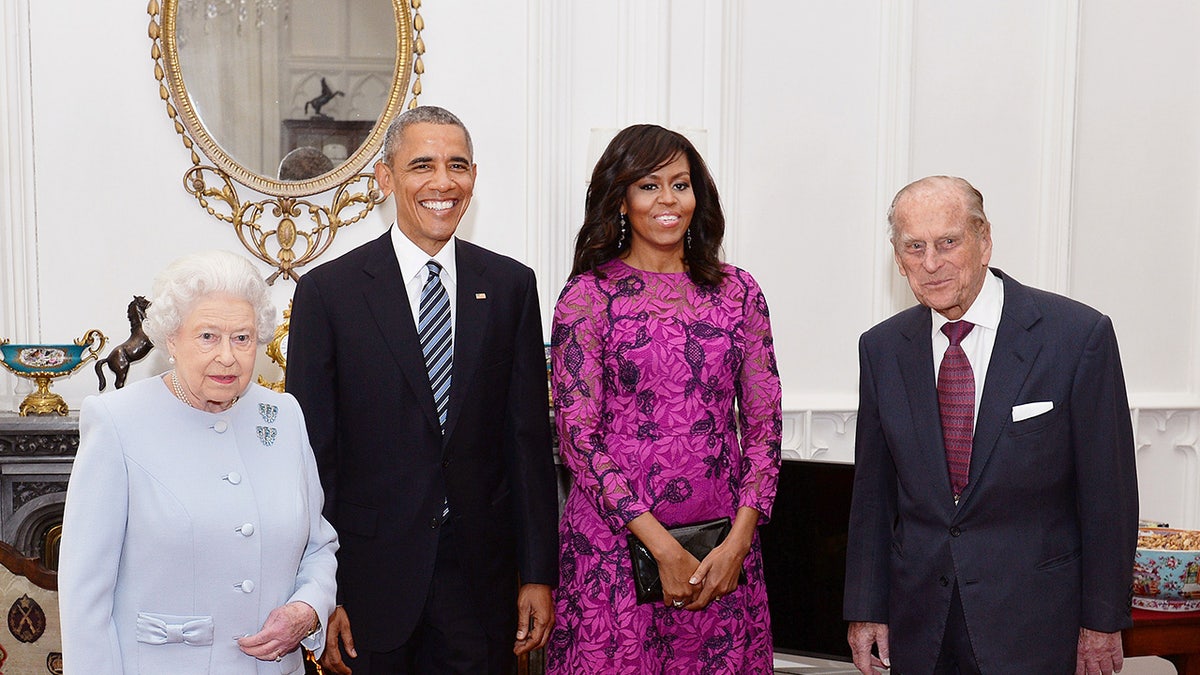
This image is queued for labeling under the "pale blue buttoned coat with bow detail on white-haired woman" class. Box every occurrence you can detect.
[59,377,337,675]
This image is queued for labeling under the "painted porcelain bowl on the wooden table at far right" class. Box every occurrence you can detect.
[1133,527,1200,611]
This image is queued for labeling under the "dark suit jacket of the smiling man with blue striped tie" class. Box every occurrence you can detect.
[287,232,558,652]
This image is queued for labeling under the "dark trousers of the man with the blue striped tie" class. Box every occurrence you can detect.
[343,522,516,675]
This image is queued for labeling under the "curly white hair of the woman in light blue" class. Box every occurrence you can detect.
[142,251,275,347]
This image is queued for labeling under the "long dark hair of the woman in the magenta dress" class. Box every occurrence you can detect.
[571,124,725,286]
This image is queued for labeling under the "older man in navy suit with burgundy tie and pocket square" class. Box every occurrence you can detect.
[844,177,1138,675]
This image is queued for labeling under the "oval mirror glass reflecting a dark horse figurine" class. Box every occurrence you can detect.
[163,0,412,196]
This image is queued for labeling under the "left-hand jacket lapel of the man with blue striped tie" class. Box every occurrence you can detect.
[362,232,438,426]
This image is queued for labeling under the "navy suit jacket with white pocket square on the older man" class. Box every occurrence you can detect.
[844,270,1138,675]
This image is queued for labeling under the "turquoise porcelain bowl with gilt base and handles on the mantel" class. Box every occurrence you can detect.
[0,328,108,416]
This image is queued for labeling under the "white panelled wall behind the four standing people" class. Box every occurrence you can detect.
[0,0,1200,527]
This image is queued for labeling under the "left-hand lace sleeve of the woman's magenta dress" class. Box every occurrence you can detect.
[551,275,650,532]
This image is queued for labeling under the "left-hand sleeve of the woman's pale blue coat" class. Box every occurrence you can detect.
[59,398,128,675]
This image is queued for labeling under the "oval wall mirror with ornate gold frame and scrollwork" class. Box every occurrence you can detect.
[148,0,425,282]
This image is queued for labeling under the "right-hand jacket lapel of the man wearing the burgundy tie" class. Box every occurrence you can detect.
[962,270,1042,501]
